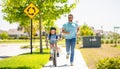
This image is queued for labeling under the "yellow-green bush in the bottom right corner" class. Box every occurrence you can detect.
[96,57,120,69]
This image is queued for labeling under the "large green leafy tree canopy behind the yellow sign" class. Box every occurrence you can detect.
[2,0,78,33]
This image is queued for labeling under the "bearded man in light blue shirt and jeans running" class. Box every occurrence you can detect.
[62,14,79,66]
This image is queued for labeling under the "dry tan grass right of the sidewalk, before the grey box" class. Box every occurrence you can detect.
[80,44,120,69]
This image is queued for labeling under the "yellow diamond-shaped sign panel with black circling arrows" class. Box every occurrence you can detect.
[24,3,39,19]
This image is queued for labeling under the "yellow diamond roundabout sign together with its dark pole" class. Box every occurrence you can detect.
[24,3,39,54]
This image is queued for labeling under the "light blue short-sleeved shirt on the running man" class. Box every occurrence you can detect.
[63,22,78,39]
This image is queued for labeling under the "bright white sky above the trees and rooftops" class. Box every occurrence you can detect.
[0,0,120,32]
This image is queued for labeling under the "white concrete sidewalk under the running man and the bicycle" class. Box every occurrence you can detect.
[42,48,89,69]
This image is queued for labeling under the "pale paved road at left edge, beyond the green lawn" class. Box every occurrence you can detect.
[0,44,30,59]
